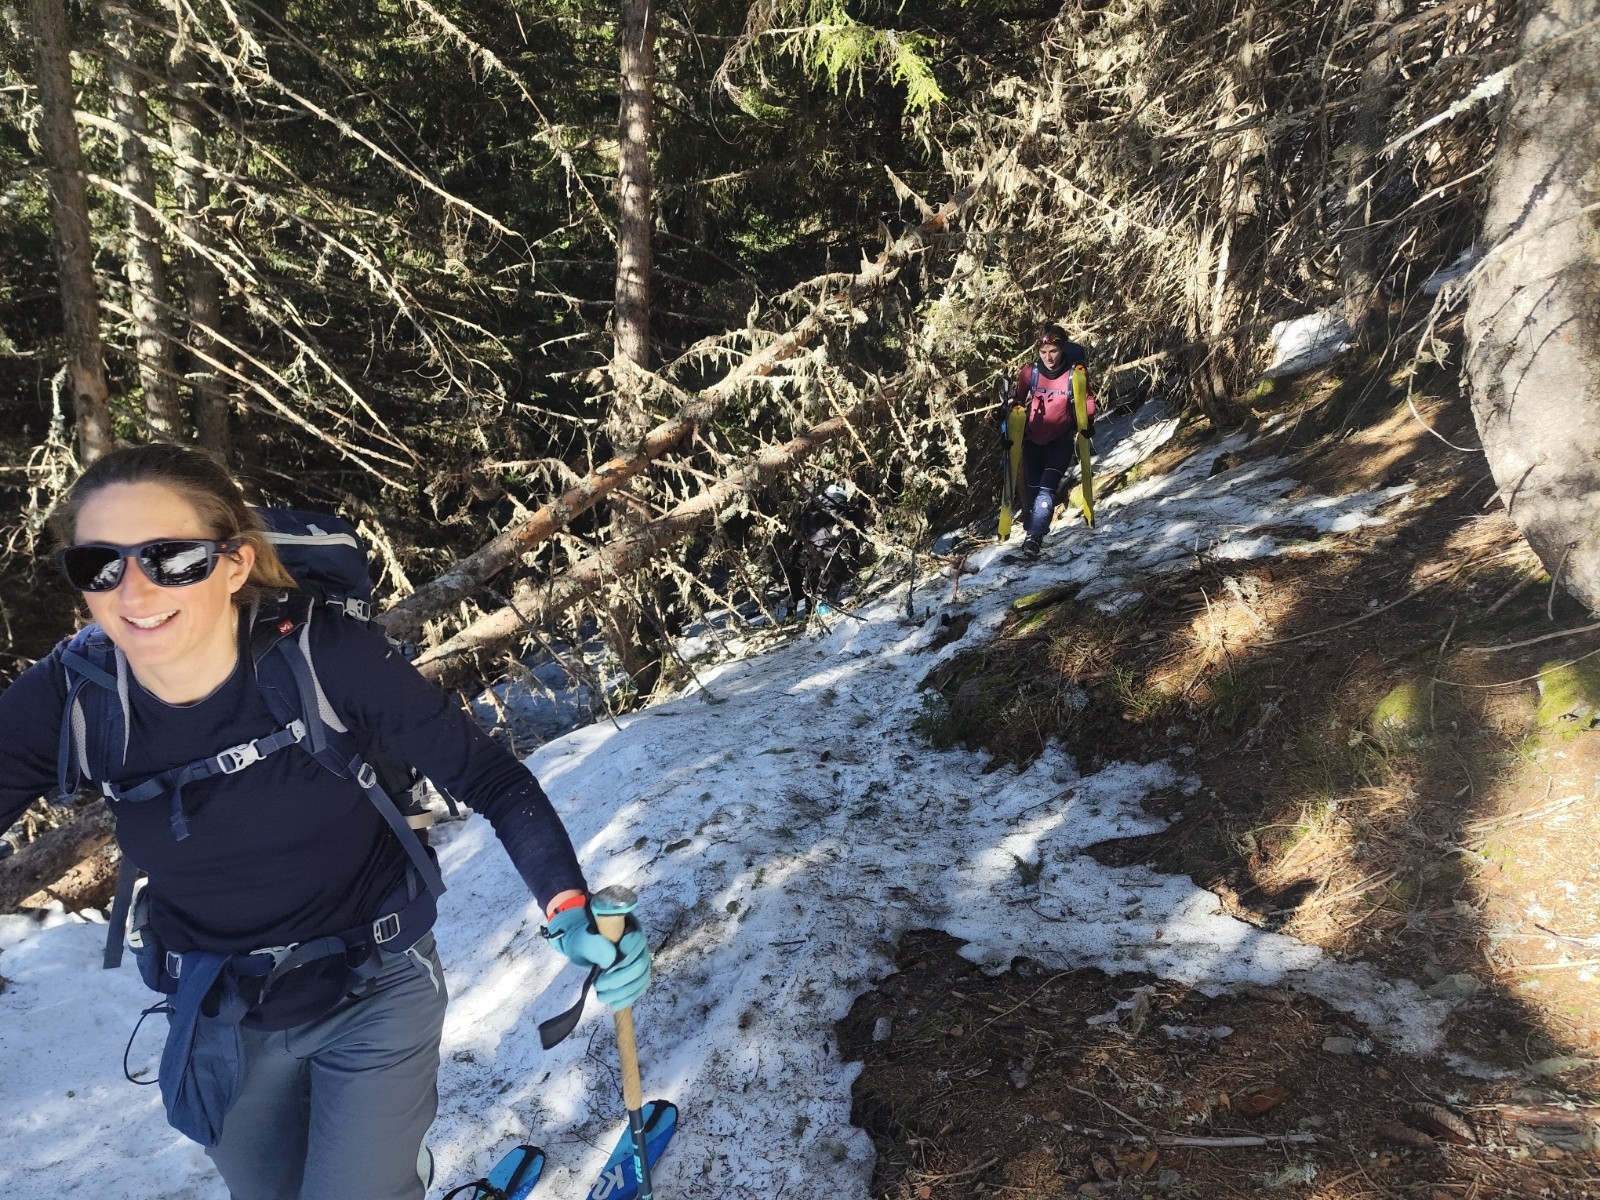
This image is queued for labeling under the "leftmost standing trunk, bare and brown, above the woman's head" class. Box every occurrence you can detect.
[29,0,112,462]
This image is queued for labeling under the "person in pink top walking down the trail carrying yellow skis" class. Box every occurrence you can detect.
[998,325,1094,560]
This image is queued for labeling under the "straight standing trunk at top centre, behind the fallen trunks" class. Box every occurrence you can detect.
[608,0,658,696]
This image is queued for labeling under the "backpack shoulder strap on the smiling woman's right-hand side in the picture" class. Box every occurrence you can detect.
[251,597,445,899]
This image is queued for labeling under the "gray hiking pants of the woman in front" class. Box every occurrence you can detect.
[206,934,446,1200]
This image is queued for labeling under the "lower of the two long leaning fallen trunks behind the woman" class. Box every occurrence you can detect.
[418,392,888,686]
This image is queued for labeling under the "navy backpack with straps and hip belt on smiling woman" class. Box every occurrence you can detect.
[58,509,454,1146]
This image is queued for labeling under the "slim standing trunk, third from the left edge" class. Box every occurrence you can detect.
[170,27,229,458]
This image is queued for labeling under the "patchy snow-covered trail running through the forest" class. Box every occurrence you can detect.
[0,426,1443,1200]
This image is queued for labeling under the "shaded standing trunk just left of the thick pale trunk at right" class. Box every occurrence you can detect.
[1339,0,1403,347]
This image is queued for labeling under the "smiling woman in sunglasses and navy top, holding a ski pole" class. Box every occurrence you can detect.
[0,445,651,1200]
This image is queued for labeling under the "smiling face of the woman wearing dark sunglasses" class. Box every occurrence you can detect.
[75,483,256,674]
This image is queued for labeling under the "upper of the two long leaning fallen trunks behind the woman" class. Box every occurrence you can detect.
[378,234,922,638]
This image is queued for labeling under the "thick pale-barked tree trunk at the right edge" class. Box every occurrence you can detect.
[1466,0,1600,611]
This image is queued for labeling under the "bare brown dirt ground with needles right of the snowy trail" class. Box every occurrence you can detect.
[840,345,1600,1200]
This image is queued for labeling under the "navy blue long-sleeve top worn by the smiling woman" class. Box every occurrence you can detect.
[0,604,586,1017]
